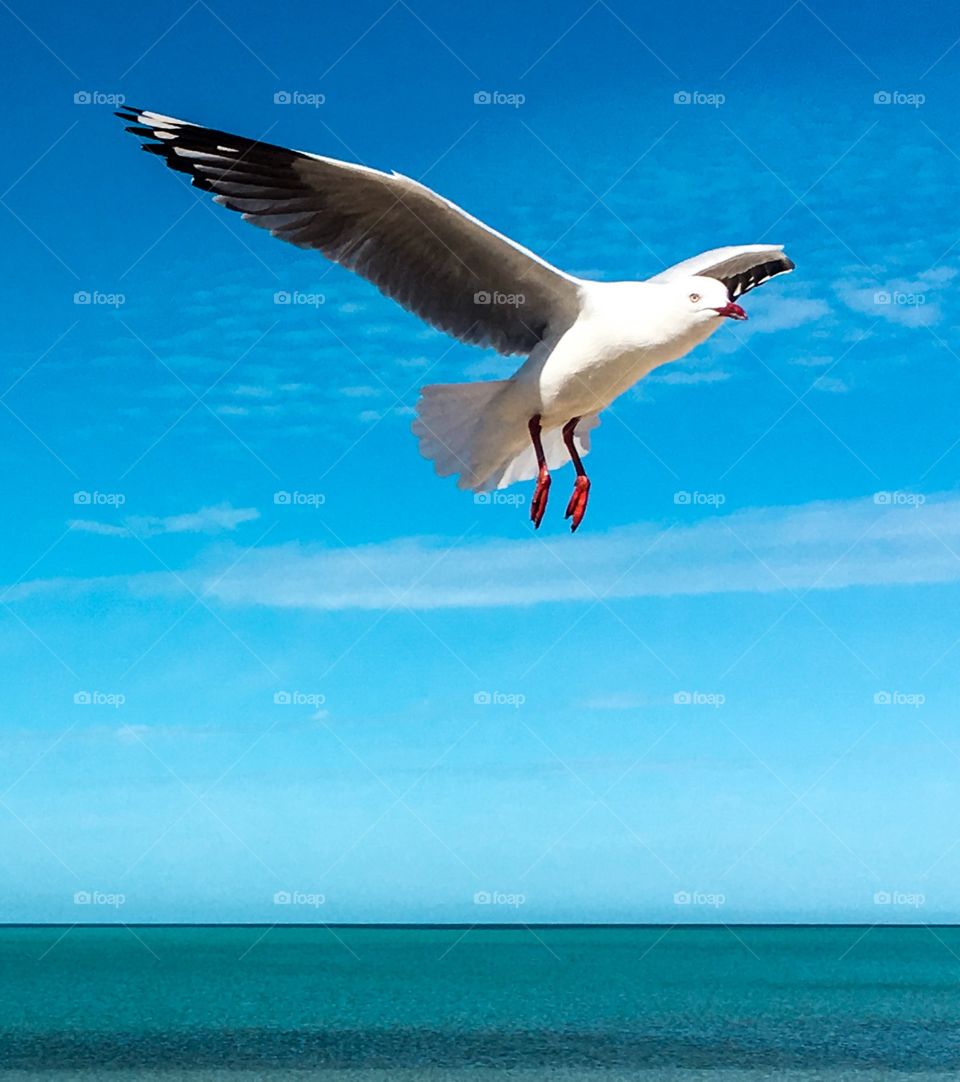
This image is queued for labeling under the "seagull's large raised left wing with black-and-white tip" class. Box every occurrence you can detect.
[117,107,580,354]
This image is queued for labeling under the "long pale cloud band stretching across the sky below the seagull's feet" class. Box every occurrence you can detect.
[28,492,960,611]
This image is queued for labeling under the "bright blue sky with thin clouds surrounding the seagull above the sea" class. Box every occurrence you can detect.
[0,0,960,922]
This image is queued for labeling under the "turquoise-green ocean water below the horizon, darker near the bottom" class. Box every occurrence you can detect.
[0,926,960,1082]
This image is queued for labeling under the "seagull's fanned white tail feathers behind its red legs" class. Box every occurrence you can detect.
[413,380,600,492]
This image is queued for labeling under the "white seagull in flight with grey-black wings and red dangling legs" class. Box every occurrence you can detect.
[117,107,793,530]
